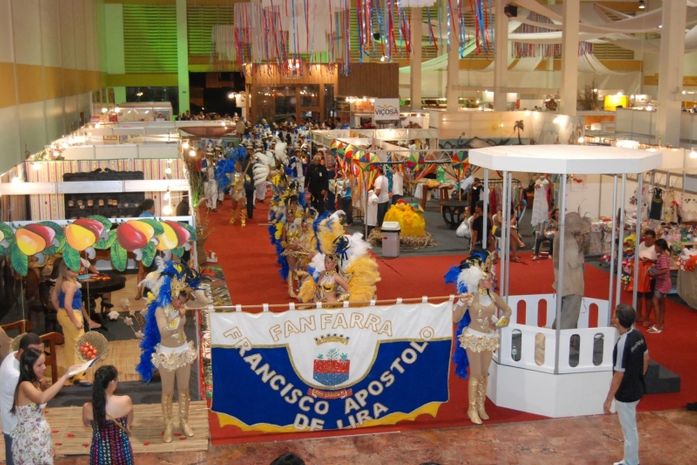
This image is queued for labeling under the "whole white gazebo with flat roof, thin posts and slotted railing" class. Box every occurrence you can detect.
[469,145,662,417]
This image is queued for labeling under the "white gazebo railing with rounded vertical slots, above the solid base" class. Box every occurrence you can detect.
[496,294,617,373]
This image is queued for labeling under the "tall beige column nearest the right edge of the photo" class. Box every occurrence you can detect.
[656,0,687,147]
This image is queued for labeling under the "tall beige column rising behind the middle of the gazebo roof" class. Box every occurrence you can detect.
[559,0,581,116]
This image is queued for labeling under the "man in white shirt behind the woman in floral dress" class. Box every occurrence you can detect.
[0,333,44,465]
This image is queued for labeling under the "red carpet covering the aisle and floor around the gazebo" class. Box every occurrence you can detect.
[206,204,697,443]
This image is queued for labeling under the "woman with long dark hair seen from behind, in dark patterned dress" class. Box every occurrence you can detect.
[82,365,133,465]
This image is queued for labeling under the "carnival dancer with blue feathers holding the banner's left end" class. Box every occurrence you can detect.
[136,261,198,443]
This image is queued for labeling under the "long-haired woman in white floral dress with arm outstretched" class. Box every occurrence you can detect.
[11,349,77,465]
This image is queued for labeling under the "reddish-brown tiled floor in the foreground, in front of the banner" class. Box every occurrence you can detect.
[51,410,697,465]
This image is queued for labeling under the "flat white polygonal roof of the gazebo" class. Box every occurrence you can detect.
[469,145,662,174]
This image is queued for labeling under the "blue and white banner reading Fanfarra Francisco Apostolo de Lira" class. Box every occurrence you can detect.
[210,302,452,432]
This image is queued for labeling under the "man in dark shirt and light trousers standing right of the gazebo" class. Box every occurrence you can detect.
[603,304,649,465]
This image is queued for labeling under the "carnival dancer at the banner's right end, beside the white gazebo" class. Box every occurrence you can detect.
[445,249,511,425]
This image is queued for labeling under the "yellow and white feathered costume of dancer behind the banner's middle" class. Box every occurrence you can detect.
[298,210,380,302]
